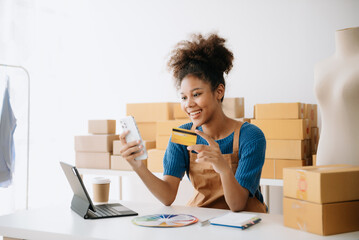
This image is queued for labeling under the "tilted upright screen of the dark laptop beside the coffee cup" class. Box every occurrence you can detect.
[60,162,95,211]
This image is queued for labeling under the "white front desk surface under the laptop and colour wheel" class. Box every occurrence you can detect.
[0,202,359,240]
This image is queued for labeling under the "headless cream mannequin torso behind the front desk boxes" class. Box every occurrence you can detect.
[314,27,359,165]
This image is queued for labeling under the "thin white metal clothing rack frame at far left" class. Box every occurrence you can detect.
[0,63,30,210]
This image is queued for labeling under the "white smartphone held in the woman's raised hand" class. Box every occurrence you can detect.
[120,116,148,160]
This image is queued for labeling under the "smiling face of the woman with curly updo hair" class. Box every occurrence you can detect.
[180,75,224,126]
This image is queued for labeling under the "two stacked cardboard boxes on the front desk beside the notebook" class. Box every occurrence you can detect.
[283,165,359,235]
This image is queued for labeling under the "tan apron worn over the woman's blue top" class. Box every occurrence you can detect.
[187,122,267,213]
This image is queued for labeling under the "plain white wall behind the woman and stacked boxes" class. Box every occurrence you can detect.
[0,0,359,212]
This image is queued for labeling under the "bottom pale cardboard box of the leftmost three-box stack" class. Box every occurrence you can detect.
[75,152,111,169]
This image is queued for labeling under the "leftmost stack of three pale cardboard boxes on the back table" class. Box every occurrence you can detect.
[75,120,119,169]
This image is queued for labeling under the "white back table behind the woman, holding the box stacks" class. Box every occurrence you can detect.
[78,168,283,206]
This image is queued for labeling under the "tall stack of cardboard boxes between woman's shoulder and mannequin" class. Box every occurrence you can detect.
[251,103,316,179]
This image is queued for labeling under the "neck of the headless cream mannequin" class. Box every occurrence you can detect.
[335,27,359,56]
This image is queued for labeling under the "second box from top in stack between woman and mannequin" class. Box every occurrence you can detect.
[251,119,311,140]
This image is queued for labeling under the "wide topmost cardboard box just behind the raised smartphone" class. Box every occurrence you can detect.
[126,102,174,122]
